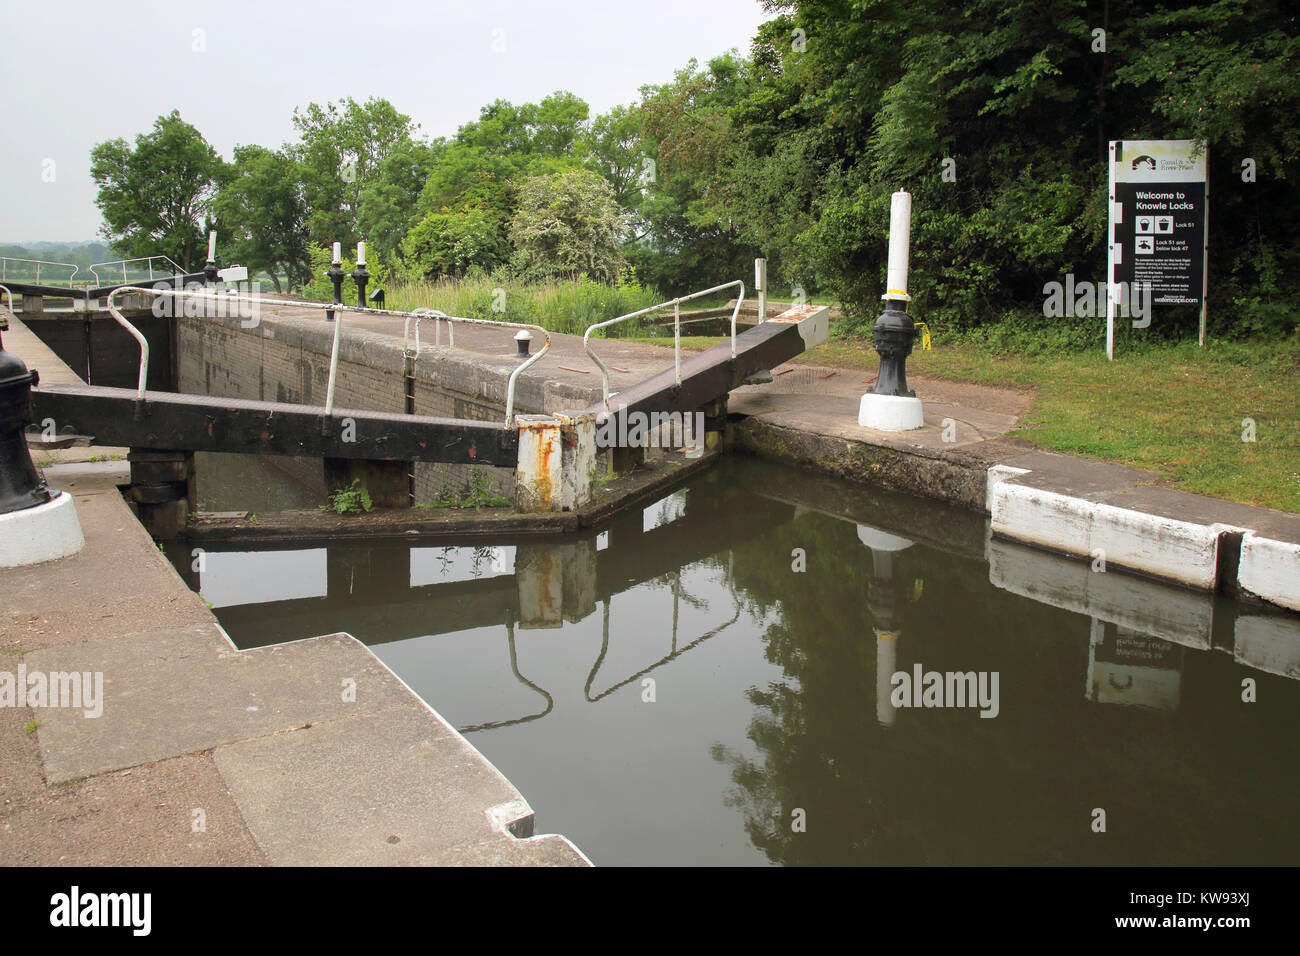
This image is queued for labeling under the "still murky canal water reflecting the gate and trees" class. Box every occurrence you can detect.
[167,462,1300,865]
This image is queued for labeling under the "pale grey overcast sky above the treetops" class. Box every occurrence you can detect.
[0,0,767,242]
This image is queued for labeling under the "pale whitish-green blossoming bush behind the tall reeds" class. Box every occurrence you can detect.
[510,169,627,281]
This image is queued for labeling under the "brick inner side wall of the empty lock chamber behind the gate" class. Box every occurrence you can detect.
[176,316,572,503]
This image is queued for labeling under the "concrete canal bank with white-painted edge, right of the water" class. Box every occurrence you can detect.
[728,364,1300,611]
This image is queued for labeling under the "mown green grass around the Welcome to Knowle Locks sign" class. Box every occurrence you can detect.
[616,329,1300,512]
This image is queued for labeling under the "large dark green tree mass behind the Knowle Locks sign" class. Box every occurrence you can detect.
[722,0,1300,336]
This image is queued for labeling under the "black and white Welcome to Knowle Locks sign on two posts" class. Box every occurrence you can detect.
[1106,139,1209,359]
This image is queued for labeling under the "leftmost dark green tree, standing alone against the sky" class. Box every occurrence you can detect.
[91,111,222,272]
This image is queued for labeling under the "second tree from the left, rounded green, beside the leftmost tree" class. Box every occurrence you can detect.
[212,146,311,291]
